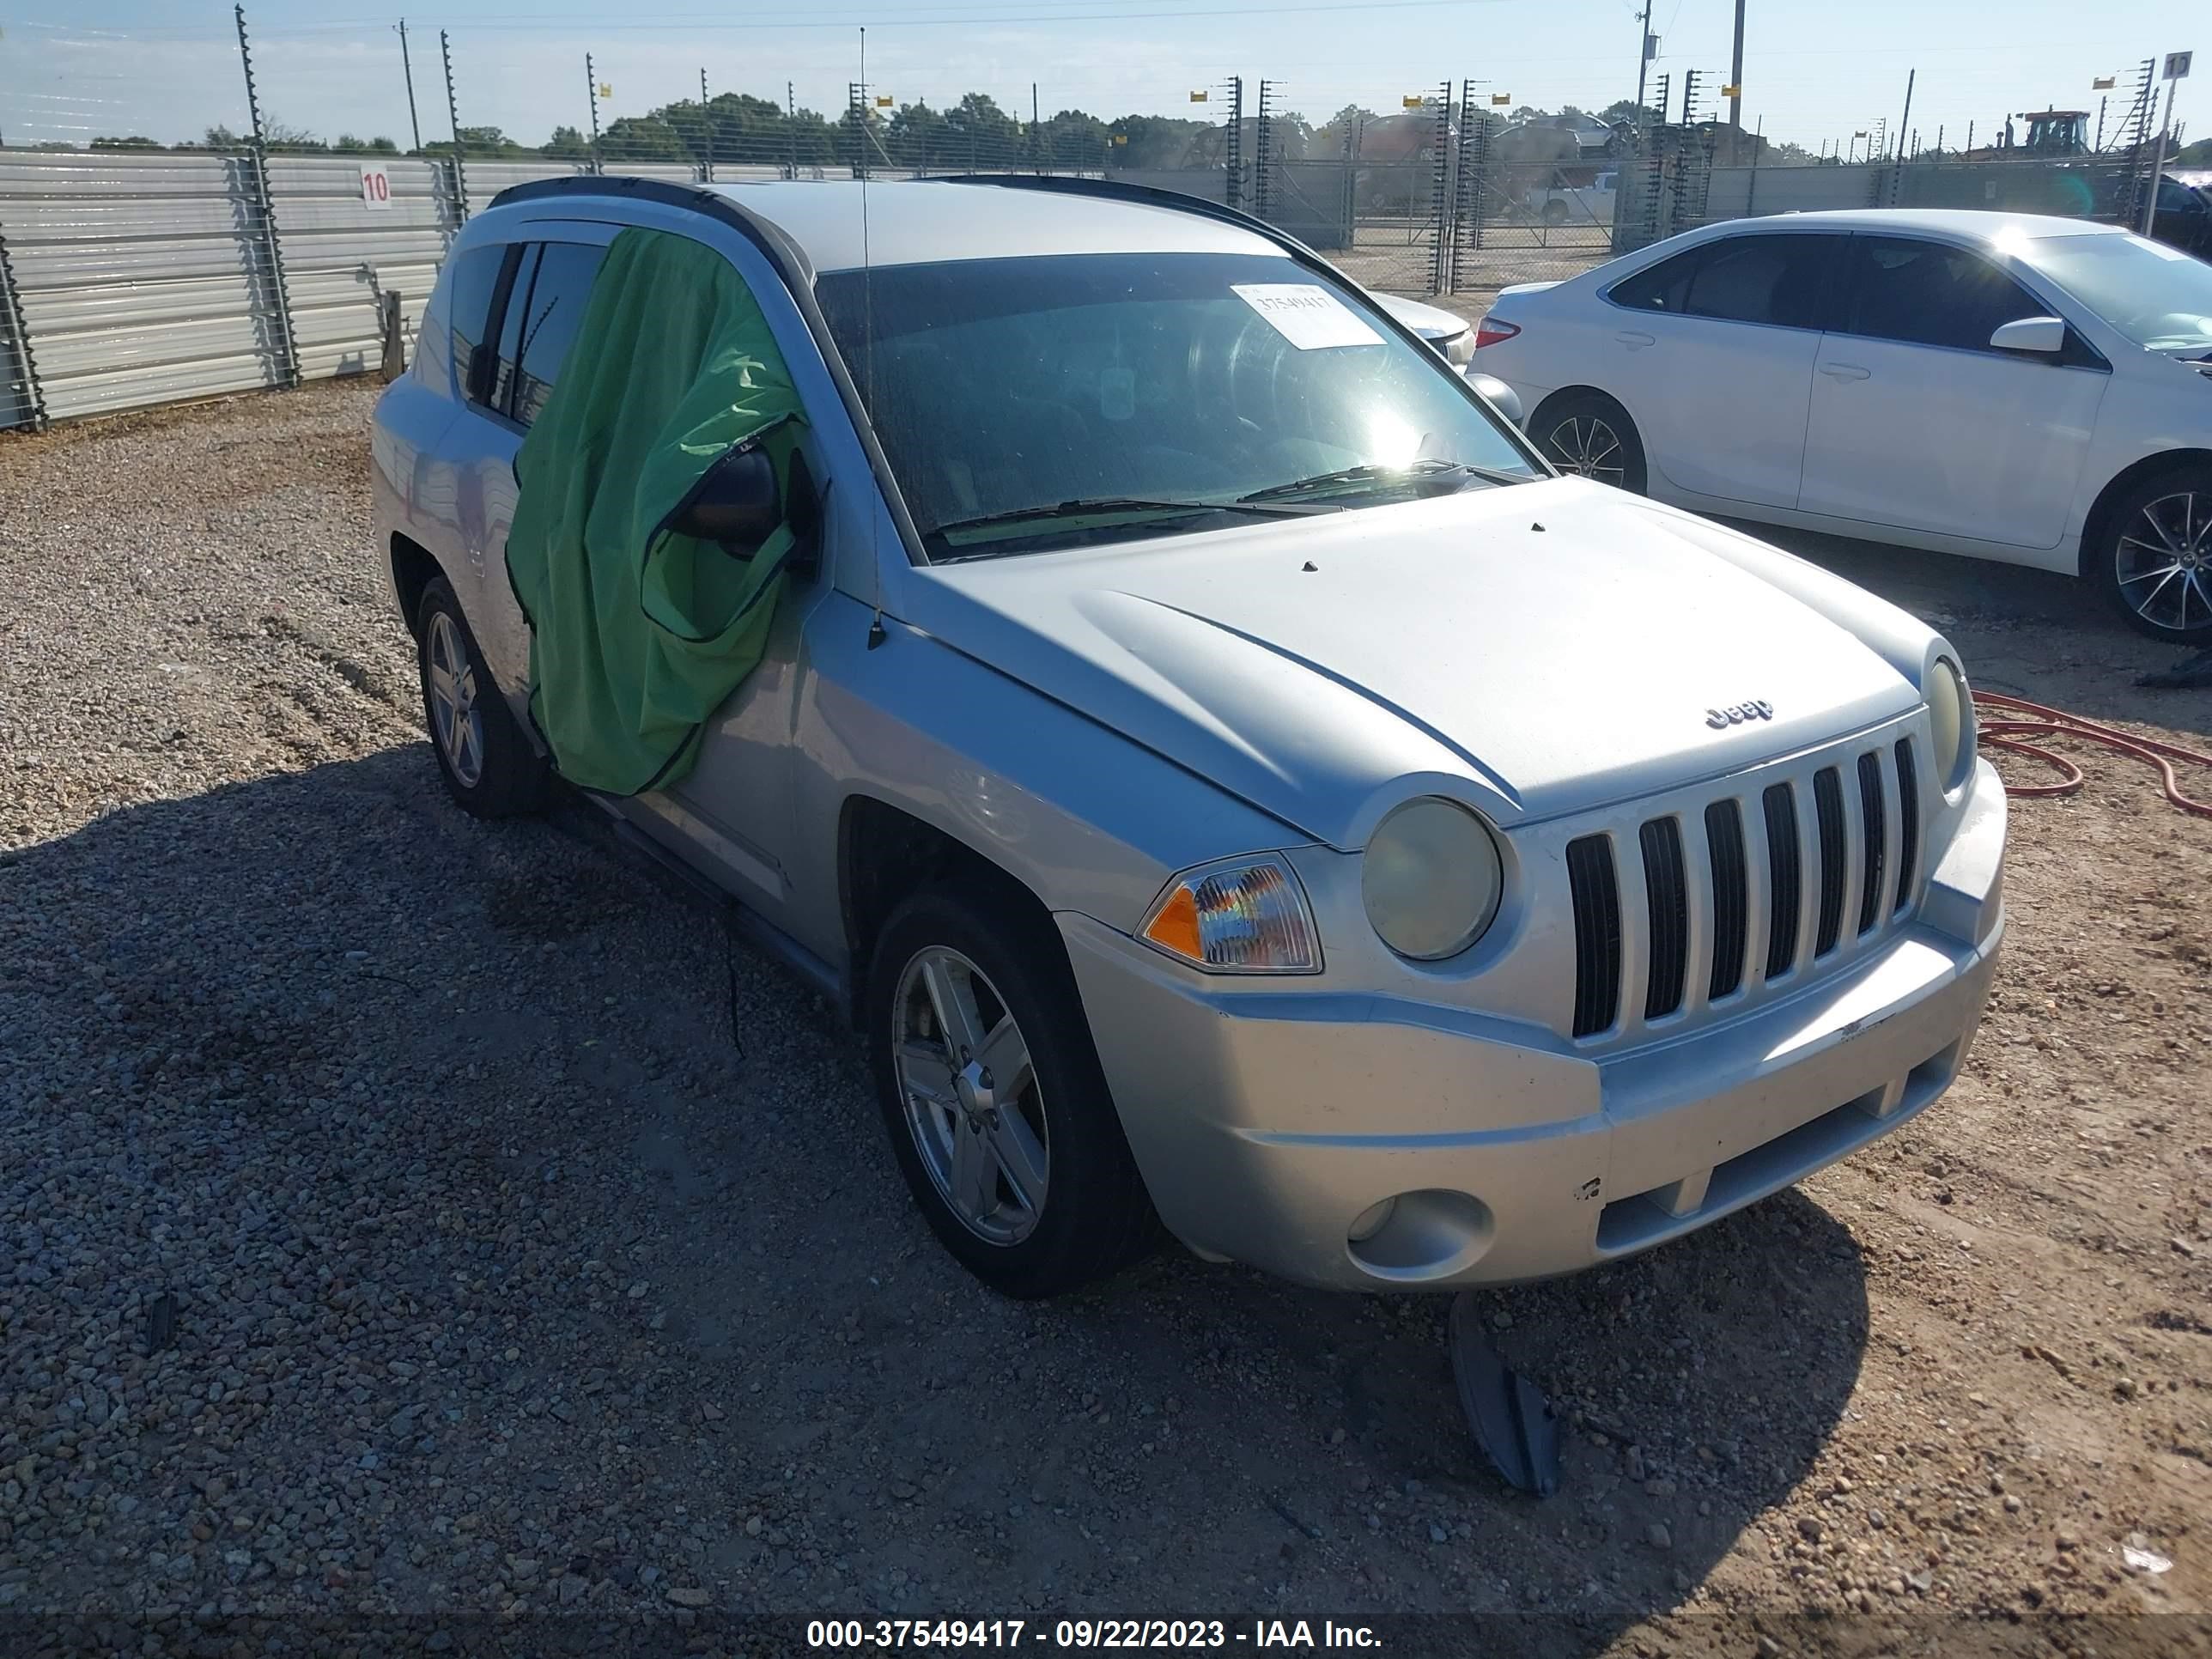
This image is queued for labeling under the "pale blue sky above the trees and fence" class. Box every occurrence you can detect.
[0,0,2212,150]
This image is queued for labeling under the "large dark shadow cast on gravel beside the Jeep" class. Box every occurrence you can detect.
[0,745,1867,1655]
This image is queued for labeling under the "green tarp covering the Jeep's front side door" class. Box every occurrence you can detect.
[507,230,799,794]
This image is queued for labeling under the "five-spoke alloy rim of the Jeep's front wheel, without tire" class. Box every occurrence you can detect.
[891,947,1051,1245]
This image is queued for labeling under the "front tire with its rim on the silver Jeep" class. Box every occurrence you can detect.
[865,887,1159,1298]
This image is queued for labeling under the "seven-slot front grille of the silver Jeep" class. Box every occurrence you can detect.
[1566,737,1920,1037]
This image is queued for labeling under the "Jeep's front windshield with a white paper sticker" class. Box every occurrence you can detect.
[817,254,1540,560]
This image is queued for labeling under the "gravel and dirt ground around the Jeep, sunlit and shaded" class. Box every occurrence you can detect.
[0,387,2212,1655]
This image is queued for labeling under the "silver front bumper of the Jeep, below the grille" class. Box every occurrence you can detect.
[1060,763,2006,1290]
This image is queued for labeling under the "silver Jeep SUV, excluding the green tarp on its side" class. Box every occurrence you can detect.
[374,177,2006,1297]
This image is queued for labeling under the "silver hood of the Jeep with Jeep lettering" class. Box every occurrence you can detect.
[898,480,1931,849]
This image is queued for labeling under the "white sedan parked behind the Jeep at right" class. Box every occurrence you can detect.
[1475,210,2212,644]
